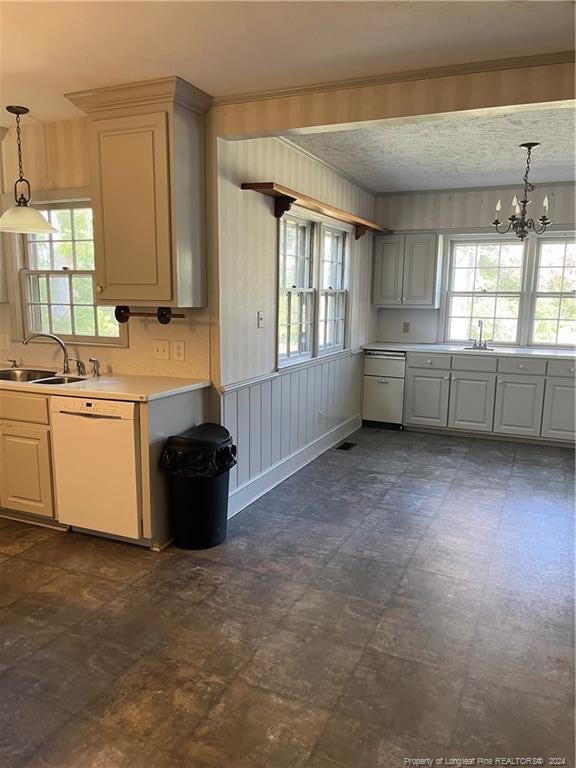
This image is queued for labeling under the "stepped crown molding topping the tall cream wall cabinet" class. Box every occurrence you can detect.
[64,76,212,115]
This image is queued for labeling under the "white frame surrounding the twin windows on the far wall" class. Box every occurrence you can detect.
[438,228,576,349]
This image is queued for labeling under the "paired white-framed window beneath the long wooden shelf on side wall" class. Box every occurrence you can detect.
[278,210,349,366]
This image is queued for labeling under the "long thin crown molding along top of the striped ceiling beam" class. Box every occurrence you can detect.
[212,51,576,107]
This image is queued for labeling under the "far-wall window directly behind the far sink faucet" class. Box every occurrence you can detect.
[446,240,525,344]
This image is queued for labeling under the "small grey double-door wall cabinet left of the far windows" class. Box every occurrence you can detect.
[372,232,441,309]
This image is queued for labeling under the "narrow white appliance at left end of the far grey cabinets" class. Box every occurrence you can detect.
[362,349,406,424]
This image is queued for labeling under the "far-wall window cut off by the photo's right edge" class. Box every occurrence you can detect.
[530,238,576,345]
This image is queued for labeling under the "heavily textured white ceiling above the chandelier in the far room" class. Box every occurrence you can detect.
[289,107,576,192]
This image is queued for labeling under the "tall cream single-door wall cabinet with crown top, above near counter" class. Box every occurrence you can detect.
[67,77,210,307]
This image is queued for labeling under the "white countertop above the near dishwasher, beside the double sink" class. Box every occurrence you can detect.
[0,374,210,402]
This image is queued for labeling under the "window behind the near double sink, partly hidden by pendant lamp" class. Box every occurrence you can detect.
[20,207,126,344]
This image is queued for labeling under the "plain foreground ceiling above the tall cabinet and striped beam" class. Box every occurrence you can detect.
[0,0,574,124]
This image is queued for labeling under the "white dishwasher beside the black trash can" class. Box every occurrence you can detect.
[50,397,141,539]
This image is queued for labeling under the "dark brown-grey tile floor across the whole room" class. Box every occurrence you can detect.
[0,429,574,768]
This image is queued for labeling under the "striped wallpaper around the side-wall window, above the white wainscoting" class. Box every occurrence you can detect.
[218,139,376,385]
